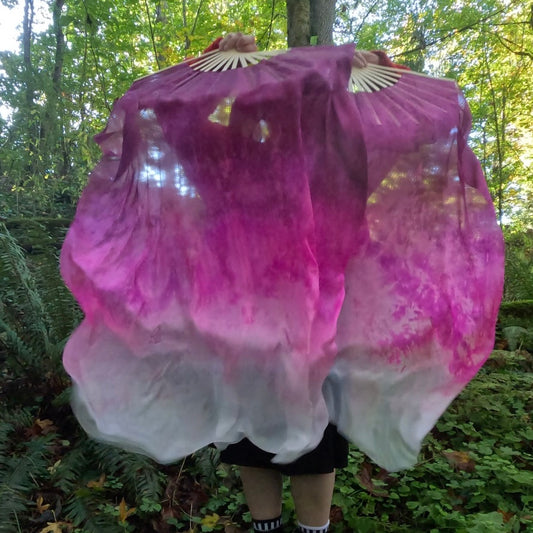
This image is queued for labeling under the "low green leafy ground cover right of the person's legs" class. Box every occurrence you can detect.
[334,351,533,533]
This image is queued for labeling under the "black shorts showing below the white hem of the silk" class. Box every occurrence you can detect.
[220,424,348,476]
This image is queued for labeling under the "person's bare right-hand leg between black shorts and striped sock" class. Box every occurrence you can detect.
[291,472,335,527]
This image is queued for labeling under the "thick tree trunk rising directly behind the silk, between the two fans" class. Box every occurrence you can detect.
[287,0,335,48]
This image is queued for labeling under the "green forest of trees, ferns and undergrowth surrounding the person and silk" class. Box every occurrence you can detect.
[0,0,533,533]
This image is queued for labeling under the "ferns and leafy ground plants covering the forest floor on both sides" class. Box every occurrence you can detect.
[0,222,533,533]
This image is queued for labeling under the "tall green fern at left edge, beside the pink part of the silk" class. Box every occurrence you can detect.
[0,223,81,383]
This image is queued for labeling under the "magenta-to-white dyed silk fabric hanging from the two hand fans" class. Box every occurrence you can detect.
[61,46,503,471]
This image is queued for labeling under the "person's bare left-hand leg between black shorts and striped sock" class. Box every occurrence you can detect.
[239,466,282,520]
